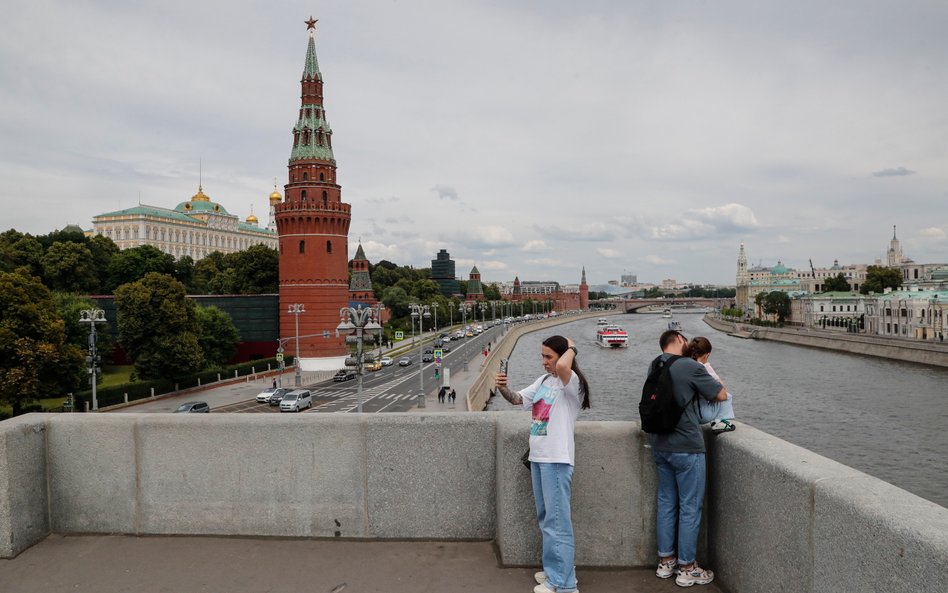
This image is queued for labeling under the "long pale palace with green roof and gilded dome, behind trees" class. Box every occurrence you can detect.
[88,184,277,260]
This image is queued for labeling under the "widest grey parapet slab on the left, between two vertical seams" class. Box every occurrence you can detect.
[138,414,366,537]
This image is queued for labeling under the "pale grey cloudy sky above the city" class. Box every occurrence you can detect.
[0,0,948,284]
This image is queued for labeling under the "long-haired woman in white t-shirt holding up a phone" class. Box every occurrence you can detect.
[494,336,589,593]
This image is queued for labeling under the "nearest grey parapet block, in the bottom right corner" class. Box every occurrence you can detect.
[812,474,948,593]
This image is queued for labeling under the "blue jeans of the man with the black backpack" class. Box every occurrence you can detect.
[652,449,706,564]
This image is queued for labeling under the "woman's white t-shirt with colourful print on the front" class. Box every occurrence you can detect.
[520,371,581,465]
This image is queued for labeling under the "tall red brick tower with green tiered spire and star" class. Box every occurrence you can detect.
[274,17,351,360]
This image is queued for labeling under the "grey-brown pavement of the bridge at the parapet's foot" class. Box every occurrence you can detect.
[0,535,720,593]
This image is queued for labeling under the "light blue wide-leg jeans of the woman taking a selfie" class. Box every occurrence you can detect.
[530,462,576,591]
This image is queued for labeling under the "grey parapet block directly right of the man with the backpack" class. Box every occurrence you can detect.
[706,423,872,593]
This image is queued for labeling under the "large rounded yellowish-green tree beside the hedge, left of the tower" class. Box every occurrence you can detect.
[115,272,204,379]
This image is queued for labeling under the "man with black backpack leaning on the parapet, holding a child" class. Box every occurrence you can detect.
[639,330,727,587]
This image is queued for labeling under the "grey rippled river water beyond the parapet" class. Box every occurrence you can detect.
[488,314,948,507]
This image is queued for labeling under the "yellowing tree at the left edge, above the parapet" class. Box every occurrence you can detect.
[0,267,83,416]
